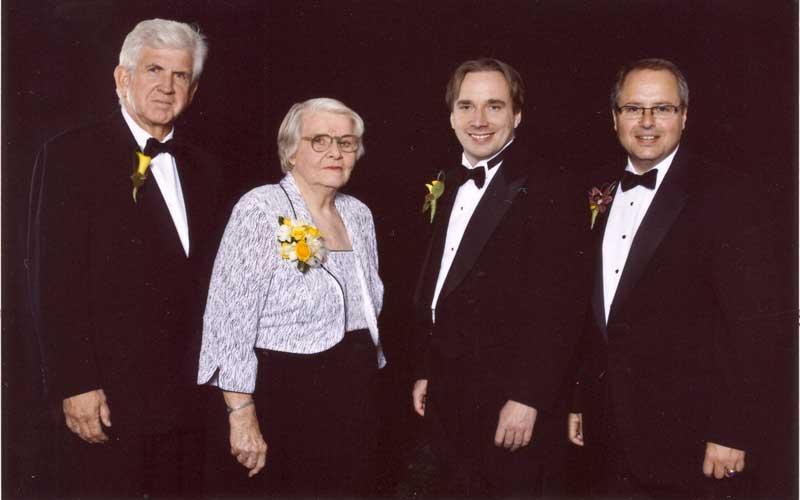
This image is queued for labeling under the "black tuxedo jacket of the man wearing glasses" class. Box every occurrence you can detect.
[580,148,785,484]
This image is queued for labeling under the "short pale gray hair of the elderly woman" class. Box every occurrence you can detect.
[278,97,364,173]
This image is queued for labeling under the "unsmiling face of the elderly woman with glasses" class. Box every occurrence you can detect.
[289,111,356,189]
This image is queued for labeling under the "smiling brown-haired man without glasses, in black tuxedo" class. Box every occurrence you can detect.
[412,59,588,497]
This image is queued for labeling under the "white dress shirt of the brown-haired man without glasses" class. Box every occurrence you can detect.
[431,140,513,323]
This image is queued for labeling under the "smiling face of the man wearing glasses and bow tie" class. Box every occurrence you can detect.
[611,69,686,172]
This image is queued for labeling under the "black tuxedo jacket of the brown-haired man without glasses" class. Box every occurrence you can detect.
[414,139,589,418]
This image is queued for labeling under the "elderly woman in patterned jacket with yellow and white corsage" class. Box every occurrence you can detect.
[198,98,385,496]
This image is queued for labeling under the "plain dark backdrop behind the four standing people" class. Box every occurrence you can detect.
[2,0,798,498]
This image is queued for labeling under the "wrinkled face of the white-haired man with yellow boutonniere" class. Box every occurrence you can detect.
[114,47,197,138]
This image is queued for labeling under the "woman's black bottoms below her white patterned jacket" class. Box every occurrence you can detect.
[230,330,378,498]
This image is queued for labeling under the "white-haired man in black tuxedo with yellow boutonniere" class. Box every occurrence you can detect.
[30,19,225,498]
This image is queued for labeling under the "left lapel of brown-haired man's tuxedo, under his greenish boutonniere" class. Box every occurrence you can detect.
[414,170,459,307]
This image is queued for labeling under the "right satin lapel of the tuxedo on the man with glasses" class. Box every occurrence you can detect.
[608,151,689,318]
